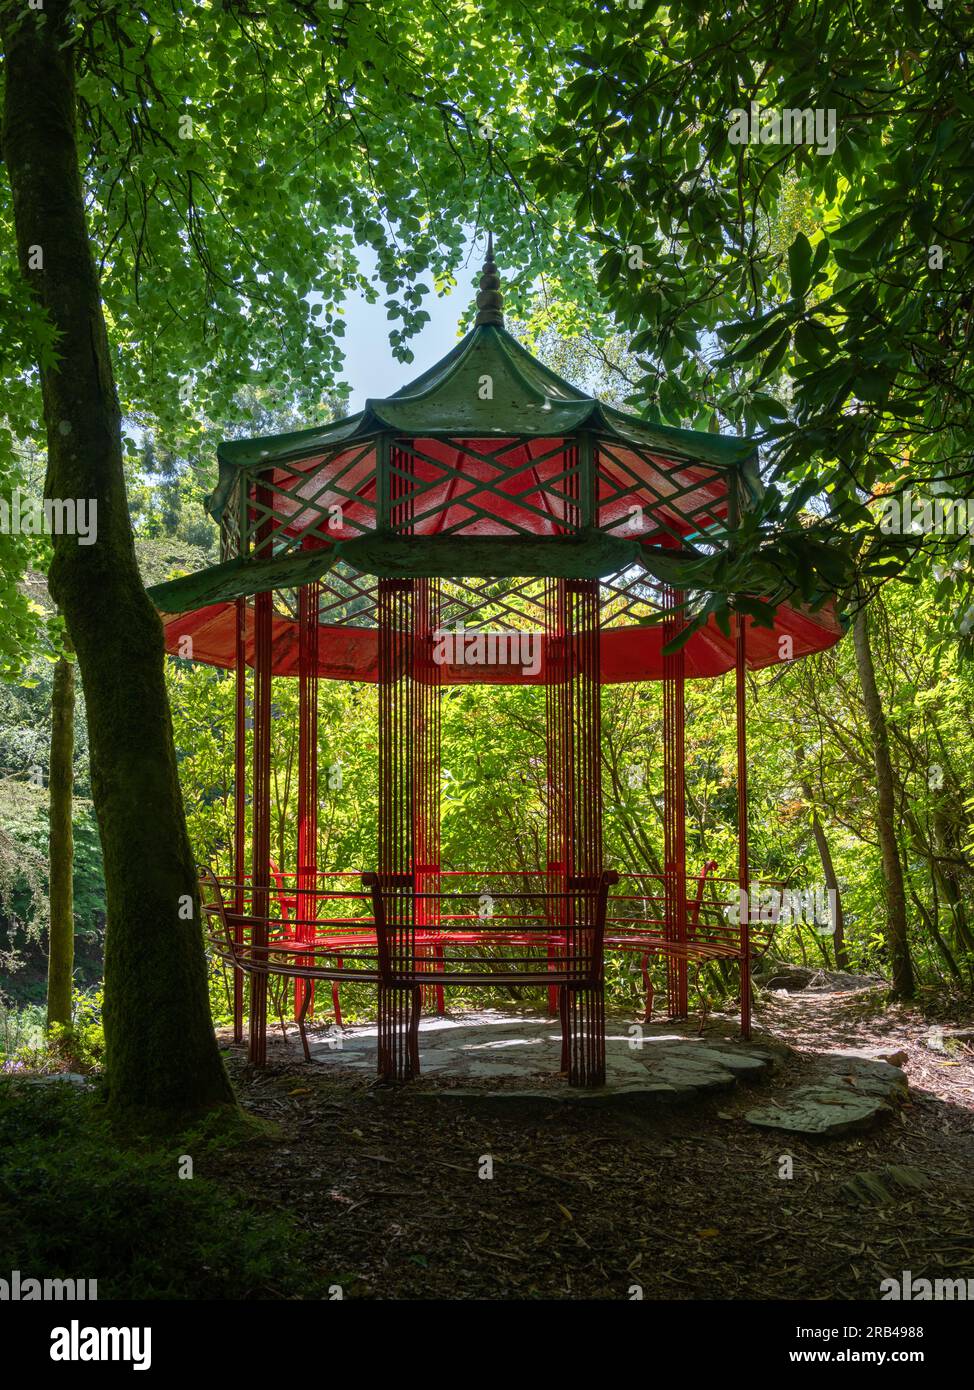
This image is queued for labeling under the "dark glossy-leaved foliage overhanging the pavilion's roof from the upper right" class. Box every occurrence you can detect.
[520,0,974,619]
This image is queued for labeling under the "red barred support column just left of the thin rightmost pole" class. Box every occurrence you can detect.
[663,585,689,1019]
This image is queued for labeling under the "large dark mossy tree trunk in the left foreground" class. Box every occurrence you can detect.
[0,0,233,1115]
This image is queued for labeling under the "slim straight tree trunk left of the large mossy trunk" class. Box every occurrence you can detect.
[47,644,75,1029]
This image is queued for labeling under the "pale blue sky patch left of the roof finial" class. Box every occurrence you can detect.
[342,247,482,413]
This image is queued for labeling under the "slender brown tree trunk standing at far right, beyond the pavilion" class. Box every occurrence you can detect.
[852,607,914,999]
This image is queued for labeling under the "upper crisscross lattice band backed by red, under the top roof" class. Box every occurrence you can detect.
[224,435,728,555]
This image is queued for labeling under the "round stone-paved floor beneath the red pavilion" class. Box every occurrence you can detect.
[305,1009,774,1105]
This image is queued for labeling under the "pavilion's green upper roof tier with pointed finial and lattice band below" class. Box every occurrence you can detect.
[186,242,760,602]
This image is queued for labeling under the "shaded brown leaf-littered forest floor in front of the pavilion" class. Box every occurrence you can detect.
[208,990,974,1300]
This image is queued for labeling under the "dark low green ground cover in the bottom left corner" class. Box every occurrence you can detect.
[0,1081,329,1298]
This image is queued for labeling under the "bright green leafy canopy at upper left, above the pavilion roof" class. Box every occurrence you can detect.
[0,0,591,433]
